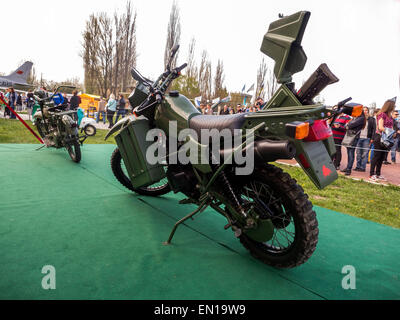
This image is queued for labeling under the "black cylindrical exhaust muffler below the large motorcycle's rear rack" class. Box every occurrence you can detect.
[220,139,296,163]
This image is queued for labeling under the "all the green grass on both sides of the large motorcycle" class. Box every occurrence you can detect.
[0,119,400,228]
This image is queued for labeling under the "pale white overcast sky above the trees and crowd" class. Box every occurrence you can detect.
[0,0,400,107]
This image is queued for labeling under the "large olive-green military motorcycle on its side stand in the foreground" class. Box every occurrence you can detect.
[106,11,360,268]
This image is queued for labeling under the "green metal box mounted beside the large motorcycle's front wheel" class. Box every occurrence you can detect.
[115,119,166,188]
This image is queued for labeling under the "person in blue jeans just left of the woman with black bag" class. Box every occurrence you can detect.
[354,107,376,172]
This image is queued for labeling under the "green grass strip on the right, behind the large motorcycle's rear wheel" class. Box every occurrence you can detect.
[275,164,400,228]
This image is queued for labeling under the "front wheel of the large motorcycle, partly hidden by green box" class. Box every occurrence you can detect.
[111,148,171,197]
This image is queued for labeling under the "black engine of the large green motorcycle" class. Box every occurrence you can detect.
[167,165,199,198]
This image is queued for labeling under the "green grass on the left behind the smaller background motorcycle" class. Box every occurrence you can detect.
[0,119,115,144]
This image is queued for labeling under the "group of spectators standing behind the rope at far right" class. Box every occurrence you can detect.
[330,98,400,181]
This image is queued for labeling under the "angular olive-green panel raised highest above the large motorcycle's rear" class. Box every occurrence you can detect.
[260,11,311,83]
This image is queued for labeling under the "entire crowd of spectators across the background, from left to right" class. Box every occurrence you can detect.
[3,88,400,181]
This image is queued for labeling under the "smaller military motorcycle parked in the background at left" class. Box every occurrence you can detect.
[32,86,83,162]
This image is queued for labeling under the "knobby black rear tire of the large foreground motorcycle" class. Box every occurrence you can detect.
[239,165,319,268]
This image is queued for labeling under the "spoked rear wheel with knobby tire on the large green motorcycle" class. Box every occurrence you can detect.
[234,165,318,268]
